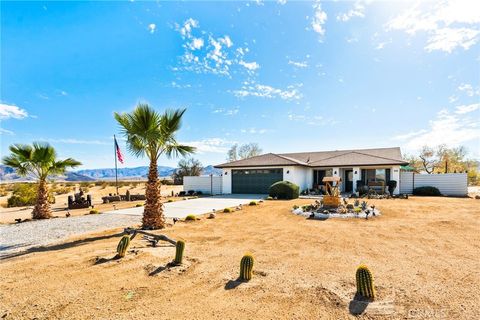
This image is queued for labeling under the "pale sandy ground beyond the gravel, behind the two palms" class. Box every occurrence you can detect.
[0,185,183,224]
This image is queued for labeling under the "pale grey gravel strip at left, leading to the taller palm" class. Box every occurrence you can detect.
[0,213,142,259]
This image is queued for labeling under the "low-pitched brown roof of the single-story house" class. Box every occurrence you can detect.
[215,147,407,168]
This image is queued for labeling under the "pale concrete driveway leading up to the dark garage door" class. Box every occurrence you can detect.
[104,194,265,218]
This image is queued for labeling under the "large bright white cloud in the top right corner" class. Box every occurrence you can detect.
[387,0,480,53]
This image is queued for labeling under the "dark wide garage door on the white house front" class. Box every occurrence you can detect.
[232,168,283,194]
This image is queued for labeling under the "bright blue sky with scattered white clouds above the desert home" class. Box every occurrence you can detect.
[0,1,480,168]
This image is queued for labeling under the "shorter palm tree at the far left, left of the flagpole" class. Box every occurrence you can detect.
[2,142,81,219]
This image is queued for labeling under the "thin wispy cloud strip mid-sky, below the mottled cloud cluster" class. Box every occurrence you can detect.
[233,81,302,100]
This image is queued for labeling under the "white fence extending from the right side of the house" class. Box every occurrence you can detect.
[400,172,468,196]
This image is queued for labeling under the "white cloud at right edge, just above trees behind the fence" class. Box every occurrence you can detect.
[393,107,480,149]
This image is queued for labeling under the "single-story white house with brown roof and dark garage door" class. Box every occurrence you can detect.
[215,147,408,194]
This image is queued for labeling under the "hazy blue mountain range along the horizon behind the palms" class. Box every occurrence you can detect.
[0,165,222,182]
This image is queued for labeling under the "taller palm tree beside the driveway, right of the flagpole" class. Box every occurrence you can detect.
[114,103,195,229]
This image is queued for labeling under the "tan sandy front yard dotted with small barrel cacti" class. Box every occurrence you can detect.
[0,197,480,319]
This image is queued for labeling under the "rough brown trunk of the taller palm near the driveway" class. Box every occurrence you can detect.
[142,160,165,229]
